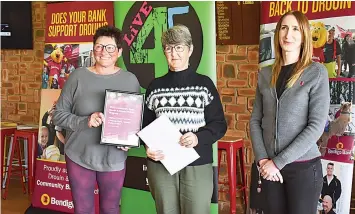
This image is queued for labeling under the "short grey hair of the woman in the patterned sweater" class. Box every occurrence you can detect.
[161,24,192,47]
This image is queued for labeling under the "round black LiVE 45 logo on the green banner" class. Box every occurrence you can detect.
[122,1,203,88]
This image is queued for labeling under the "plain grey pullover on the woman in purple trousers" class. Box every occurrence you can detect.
[53,68,140,171]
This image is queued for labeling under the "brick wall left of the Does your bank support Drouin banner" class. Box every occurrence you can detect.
[1,2,46,124]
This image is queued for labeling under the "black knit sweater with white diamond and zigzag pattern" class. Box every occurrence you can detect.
[143,68,227,166]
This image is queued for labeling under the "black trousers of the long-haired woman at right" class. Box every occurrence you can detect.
[262,158,323,214]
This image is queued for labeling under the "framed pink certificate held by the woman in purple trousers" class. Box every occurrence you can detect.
[101,89,144,147]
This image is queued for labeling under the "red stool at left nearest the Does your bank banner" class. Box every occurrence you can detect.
[3,129,38,199]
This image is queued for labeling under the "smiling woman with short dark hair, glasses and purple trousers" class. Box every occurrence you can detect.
[53,26,140,214]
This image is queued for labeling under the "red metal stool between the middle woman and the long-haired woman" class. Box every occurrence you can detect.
[218,139,248,214]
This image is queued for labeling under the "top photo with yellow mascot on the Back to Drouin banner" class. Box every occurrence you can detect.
[259,16,355,78]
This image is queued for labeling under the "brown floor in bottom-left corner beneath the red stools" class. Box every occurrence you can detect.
[1,180,31,214]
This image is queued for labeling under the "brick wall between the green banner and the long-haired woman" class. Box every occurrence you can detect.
[217,45,259,213]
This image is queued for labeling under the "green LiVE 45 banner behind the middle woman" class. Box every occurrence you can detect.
[114,1,218,214]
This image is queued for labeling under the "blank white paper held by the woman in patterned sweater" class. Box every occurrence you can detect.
[137,115,200,175]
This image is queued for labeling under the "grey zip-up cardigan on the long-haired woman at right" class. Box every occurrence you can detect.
[250,63,330,170]
